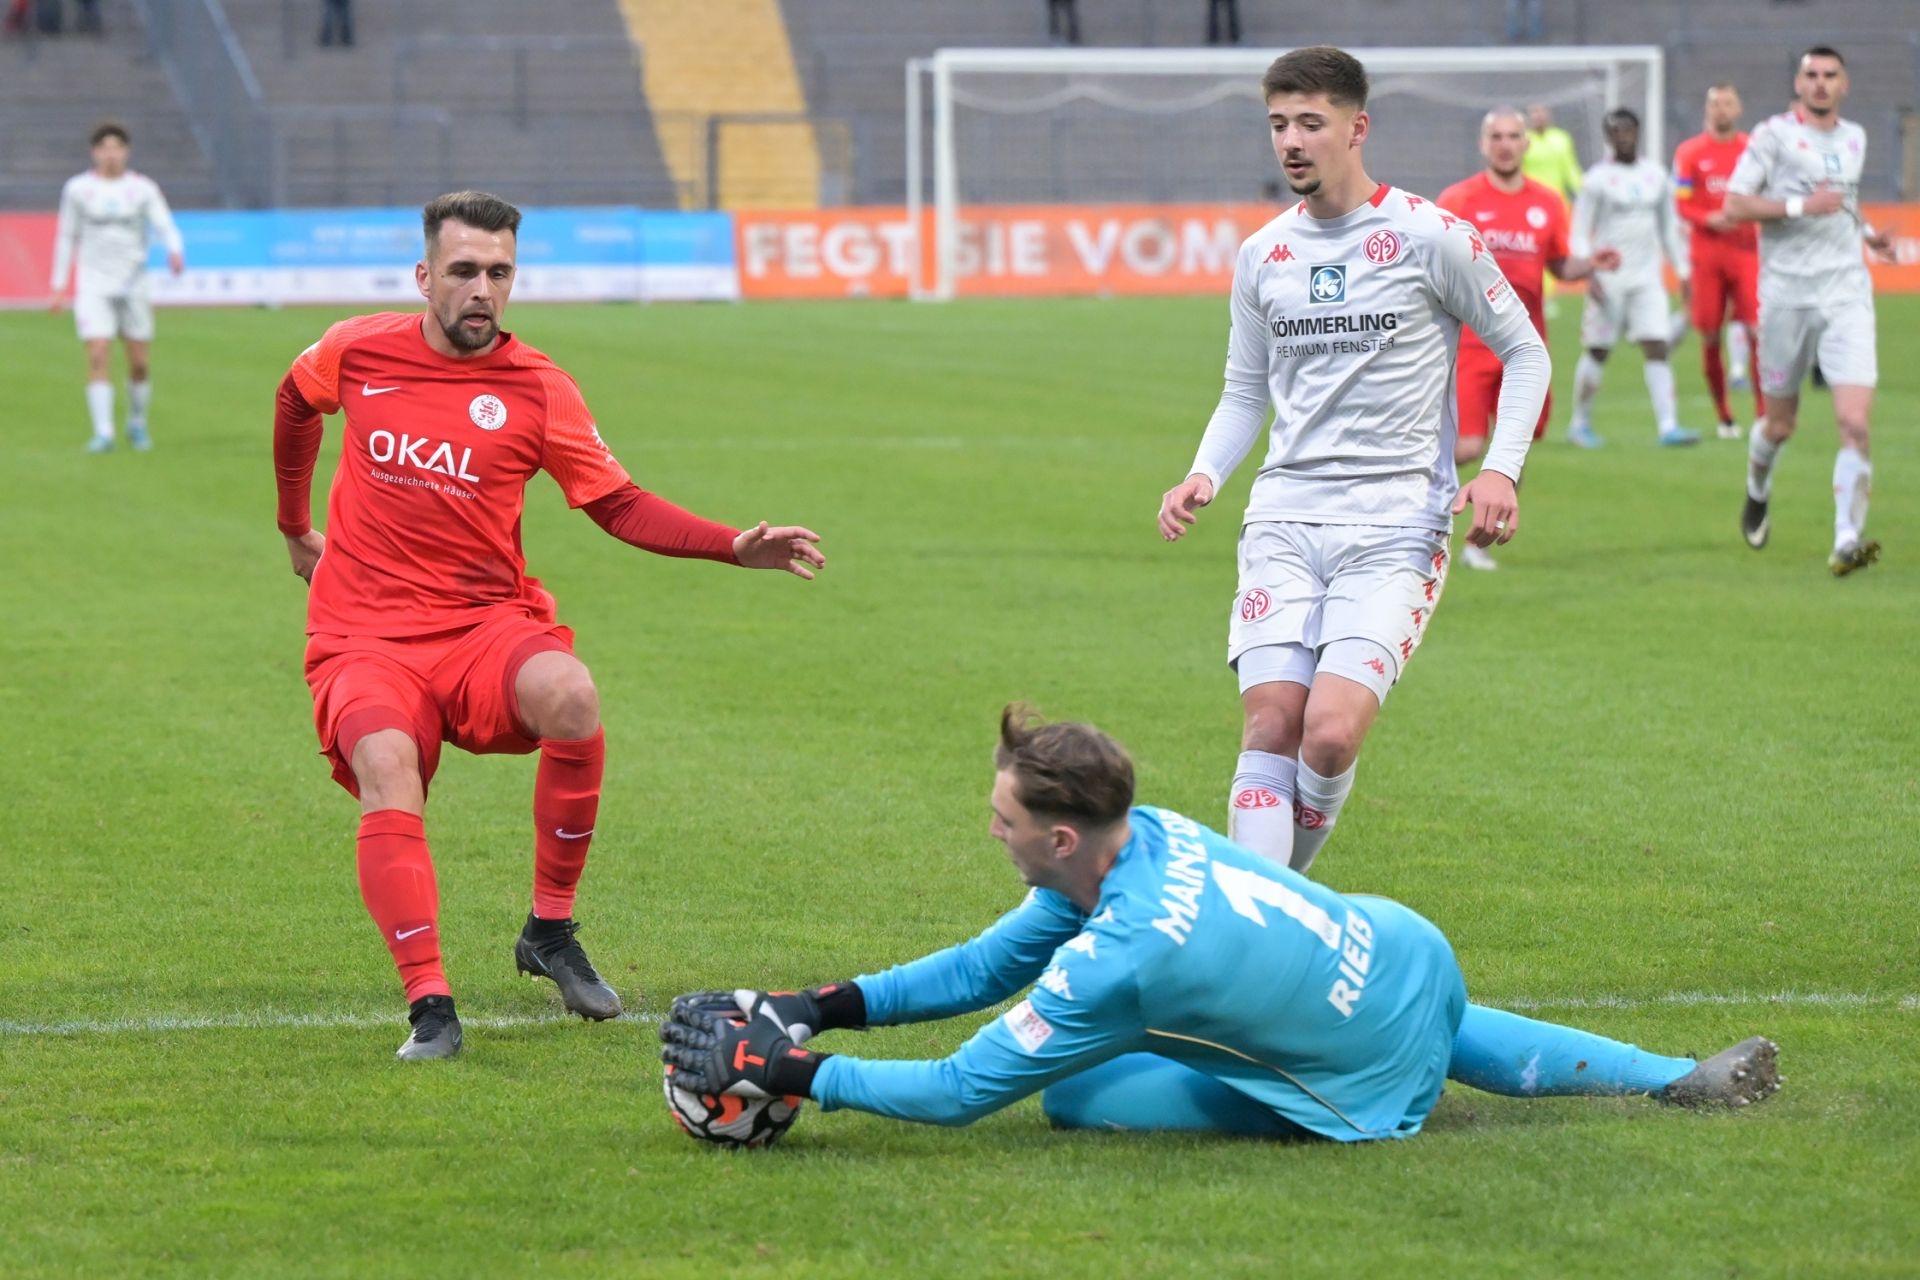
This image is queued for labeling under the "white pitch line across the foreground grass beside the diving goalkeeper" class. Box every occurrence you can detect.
[0,990,1920,1036]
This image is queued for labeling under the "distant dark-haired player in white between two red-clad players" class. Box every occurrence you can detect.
[1567,107,1699,449]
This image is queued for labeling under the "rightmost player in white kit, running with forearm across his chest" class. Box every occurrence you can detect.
[1726,44,1893,578]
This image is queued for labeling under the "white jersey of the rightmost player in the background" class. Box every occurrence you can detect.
[1726,111,1874,307]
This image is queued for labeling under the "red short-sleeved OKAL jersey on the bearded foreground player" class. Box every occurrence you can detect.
[292,311,630,639]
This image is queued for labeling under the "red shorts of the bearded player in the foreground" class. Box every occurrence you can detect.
[307,606,574,796]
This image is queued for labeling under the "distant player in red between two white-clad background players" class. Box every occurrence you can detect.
[1674,83,1766,439]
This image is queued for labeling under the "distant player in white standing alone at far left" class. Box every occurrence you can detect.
[54,121,186,453]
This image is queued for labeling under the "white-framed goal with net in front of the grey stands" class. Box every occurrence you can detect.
[906,46,1667,297]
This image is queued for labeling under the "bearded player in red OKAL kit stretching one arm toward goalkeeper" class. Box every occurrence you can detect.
[273,192,826,1059]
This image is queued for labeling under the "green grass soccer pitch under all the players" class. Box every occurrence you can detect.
[0,299,1920,1276]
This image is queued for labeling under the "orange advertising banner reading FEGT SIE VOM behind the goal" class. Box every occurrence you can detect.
[733,203,1920,297]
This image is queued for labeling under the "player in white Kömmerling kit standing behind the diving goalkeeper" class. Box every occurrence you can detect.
[1160,48,1551,871]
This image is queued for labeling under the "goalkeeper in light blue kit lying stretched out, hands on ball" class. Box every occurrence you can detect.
[660,706,1780,1142]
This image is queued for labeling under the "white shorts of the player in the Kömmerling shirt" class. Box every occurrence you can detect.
[1227,522,1450,693]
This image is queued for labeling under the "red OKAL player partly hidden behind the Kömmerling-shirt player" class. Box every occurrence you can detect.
[1440,107,1620,568]
